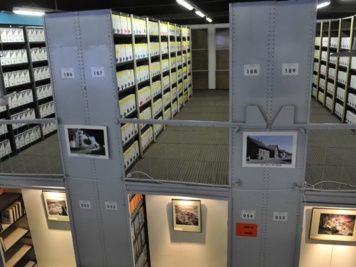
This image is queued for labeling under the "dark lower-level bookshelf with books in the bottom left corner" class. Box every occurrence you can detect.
[0,193,36,267]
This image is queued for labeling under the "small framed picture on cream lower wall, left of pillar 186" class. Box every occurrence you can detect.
[43,192,69,222]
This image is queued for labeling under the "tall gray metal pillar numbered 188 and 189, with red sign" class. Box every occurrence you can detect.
[230,0,316,267]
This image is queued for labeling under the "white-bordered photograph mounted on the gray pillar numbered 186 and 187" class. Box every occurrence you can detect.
[64,125,109,159]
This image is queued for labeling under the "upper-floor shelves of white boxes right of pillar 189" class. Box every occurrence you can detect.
[312,16,356,124]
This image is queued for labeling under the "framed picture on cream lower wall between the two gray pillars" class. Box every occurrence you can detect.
[172,199,202,233]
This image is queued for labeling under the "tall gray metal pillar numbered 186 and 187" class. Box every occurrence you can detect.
[44,10,133,267]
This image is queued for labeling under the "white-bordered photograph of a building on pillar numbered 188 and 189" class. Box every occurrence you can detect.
[242,132,297,168]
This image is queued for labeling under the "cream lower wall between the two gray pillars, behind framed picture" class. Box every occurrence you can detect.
[146,195,228,267]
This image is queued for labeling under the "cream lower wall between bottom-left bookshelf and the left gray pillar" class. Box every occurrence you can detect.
[22,189,76,267]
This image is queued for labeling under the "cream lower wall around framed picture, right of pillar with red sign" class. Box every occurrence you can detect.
[299,206,356,267]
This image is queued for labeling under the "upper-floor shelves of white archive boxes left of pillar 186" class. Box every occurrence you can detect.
[0,25,56,158]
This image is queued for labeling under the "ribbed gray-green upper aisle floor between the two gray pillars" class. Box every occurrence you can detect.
[130,90,229,185]
